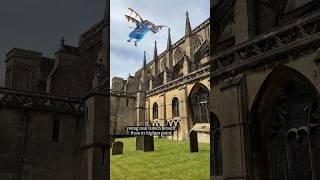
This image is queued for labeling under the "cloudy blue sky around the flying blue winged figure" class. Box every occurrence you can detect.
[110,0,210,79]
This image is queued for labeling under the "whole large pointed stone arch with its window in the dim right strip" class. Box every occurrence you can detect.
[249,65,320,180]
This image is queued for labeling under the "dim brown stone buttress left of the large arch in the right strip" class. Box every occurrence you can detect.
[220,74,250,180]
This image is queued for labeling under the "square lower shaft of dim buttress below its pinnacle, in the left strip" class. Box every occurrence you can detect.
[80,93,110,180]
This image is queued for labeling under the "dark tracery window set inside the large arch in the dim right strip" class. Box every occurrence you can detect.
[267,80,313,179]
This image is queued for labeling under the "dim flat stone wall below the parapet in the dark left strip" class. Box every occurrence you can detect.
[0,106,83,180]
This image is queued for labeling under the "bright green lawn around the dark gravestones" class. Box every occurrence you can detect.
[110,138,210,180]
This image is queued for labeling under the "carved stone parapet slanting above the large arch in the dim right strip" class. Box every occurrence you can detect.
[210,11,320,79]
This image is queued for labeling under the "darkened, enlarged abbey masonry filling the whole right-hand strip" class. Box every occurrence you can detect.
[210,0,320,180]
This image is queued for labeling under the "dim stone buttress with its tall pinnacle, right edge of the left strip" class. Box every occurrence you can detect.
[79,1,110,180]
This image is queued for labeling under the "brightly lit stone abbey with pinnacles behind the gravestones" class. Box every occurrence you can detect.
[110,12,210,142]
